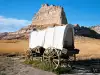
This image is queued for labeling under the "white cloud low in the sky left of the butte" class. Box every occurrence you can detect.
[0,16,31,32]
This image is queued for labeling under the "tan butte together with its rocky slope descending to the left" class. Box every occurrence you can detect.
[0,4,68,40]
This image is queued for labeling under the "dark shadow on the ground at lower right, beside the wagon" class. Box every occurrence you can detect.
[72,59,100,73]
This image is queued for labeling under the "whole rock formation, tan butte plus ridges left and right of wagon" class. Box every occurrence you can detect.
[0,4,100,40]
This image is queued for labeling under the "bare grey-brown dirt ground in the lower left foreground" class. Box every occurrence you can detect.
[0,57,55,75]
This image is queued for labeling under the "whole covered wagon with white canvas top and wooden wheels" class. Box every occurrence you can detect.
[29,24,79,68]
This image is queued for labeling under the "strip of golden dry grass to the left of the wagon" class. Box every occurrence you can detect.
[0,40,28,53]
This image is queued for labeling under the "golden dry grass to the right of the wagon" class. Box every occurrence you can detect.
[75,37,100,59]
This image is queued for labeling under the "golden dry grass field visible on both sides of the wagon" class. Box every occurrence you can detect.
[0,37,100,59]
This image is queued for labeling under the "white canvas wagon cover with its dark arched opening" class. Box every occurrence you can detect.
[29,24,74,50]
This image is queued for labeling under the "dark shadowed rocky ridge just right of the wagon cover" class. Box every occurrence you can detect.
[74,24,100,39]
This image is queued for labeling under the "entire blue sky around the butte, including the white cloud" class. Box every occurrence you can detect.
[0,0,100,32]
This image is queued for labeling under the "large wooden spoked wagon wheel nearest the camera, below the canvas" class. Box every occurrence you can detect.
[43,48,61,69]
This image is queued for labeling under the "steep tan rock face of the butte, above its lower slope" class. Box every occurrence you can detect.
[32,4,68,25]
